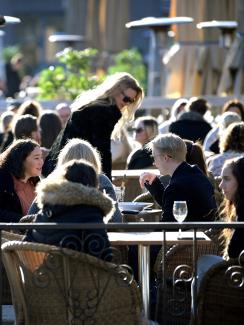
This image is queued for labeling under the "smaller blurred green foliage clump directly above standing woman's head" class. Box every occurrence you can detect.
[108,48,146,90]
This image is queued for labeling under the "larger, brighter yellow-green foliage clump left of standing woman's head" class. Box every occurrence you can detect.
[38,48,101,100]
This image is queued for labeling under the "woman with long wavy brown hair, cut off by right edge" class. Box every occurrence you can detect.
[194,157,244,287]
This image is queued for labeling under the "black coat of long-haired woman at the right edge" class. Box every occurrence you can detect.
[228,200,244,258]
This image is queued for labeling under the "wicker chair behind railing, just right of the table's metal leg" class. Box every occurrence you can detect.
[154,238,221,325]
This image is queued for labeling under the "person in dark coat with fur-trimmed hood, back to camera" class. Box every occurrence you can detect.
[24,160,114,260]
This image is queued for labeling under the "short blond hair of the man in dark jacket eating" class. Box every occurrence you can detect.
[150,133,187,162]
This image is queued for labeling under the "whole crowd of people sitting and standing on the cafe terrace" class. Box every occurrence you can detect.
[0,73,244,318]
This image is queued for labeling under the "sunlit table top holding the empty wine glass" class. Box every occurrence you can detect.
[108,231,211,246]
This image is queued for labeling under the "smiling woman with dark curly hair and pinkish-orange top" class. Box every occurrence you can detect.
[0,140,43,222]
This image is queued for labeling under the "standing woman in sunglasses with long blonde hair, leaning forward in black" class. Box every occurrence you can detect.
[43,73,143,178]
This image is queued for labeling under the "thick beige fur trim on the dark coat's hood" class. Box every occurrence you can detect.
[36,178,115,217]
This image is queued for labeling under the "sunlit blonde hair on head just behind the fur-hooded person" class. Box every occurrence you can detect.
[57,138,102,174]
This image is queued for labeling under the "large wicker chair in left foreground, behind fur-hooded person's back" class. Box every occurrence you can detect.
[2,241,145,325]
